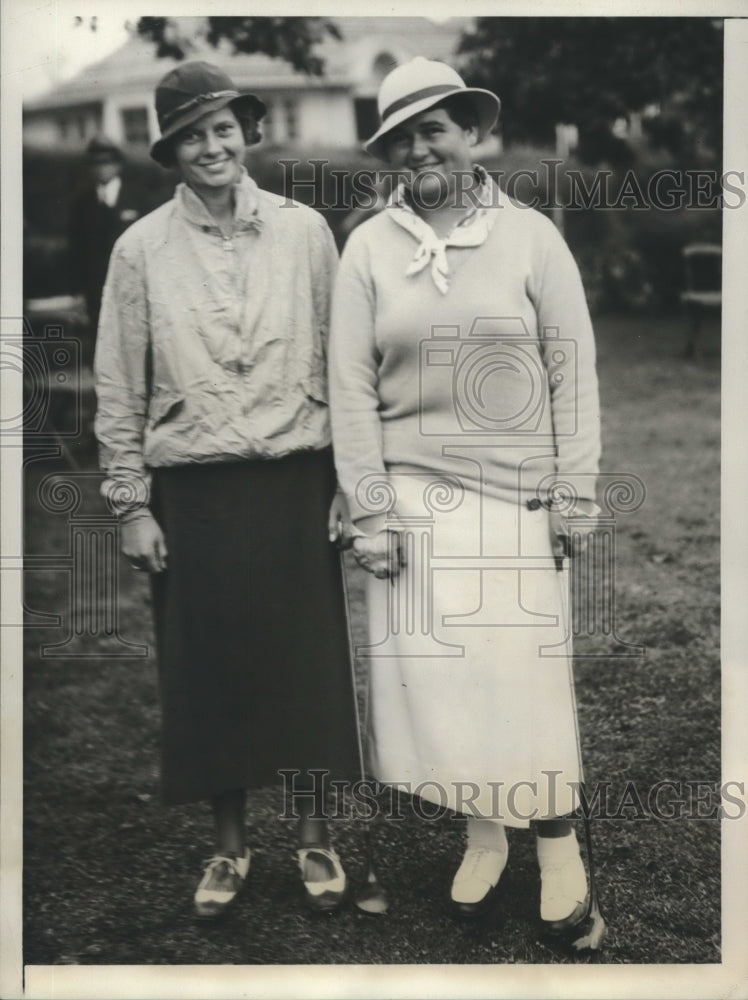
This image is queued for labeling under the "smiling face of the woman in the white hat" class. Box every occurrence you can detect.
[387,108,478,205]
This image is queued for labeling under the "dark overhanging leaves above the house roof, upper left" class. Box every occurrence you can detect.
[137,17,340,76]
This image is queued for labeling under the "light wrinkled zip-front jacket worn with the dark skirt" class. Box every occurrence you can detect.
[95,172,337,512]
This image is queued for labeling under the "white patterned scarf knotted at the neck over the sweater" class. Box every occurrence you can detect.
[387,165,498,295]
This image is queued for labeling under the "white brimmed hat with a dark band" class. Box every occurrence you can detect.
[364,56,501,160]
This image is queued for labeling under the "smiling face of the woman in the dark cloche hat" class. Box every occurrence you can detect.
[174,107,246,192]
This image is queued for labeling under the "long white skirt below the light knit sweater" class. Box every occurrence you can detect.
[359,473,581,827]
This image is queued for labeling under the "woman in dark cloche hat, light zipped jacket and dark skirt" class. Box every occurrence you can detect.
[96,62,358,920]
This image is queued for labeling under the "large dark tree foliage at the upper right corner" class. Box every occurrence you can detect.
[460,17,723,161]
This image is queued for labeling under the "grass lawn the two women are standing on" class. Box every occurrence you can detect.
[23,308,730,965]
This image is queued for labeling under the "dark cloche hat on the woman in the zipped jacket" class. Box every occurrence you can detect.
[151,61,267,166]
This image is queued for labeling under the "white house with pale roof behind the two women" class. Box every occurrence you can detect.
[23,17,470,151]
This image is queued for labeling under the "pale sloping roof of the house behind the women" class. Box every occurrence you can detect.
[25,17,471,112]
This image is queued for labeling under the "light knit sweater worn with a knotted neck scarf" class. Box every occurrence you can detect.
[330,182,600,525]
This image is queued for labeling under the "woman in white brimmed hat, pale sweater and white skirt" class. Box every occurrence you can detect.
[330,58,600,932]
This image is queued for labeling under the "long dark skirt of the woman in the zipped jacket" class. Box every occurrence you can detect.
[154,450,359,803]
